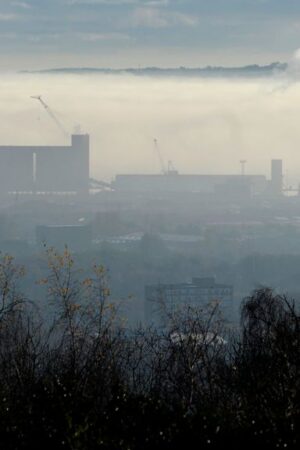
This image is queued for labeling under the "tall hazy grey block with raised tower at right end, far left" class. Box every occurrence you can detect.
[0,134,89,195]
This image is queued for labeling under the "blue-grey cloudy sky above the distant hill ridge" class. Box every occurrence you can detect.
[0,0,300,69]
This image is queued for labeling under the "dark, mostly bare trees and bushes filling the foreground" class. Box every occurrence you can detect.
[0,249,300,450]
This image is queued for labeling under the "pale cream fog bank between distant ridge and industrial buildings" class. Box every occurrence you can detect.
[0,66,300,183]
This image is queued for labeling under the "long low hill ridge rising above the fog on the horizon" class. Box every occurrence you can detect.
[23,62,288,77]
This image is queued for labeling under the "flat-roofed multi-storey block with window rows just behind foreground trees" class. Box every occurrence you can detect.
[145,277,233,325]
